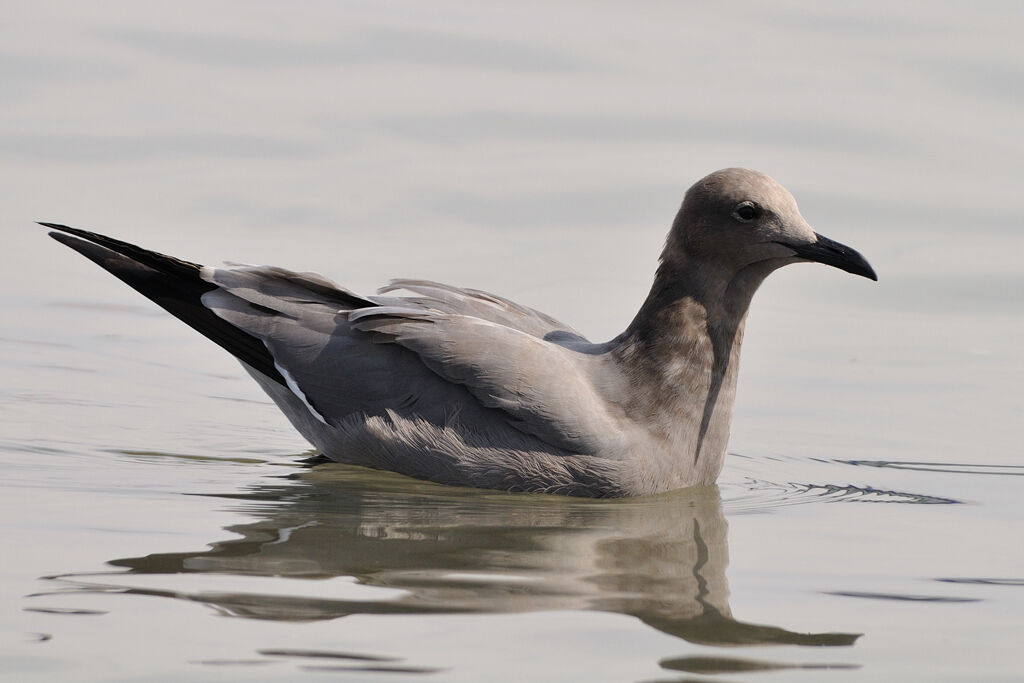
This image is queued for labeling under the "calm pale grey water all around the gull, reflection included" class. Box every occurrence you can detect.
[0,2,1024,681]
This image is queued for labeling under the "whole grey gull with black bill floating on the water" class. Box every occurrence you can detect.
[41,168,878,498]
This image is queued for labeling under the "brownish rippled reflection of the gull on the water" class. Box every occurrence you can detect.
[96,464,858,645]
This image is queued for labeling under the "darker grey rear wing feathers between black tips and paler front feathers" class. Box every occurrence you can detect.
[203,266,495,427]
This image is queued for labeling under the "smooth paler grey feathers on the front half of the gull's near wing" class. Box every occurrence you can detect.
[349,306,624,455]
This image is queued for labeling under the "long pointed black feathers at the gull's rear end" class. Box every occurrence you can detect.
[40,223,287,386]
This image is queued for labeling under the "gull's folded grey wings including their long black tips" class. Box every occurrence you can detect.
[47,224,623,462]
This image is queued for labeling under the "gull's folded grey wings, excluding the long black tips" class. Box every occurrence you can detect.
[203,267,623,455]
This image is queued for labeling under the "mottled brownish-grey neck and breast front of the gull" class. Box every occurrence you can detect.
[612,258,773,485]
